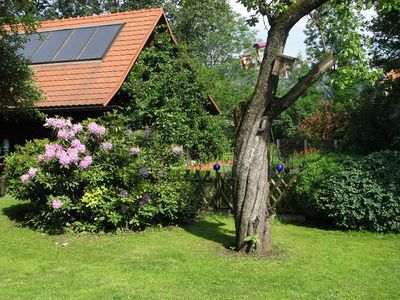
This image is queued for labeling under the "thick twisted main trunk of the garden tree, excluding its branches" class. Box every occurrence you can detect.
[233,28,288,253]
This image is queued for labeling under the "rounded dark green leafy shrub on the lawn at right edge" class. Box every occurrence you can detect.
[296,151,400,232]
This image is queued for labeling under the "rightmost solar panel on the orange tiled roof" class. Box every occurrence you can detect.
[78,24,122,60]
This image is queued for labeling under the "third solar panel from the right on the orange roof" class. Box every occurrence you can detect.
[31,29,72,63]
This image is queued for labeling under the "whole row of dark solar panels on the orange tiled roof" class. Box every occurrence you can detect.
[19,24,123,64]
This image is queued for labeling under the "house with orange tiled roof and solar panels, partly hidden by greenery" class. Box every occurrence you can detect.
[0,8,220,152]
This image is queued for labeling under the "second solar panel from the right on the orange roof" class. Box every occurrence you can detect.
[54,27,96,61]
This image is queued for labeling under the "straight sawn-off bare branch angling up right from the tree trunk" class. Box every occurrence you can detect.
[271,53,336,118]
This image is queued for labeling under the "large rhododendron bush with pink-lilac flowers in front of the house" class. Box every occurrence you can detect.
[6,115,199,232]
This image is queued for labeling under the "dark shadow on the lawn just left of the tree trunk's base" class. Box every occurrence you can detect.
[184,217,235,249]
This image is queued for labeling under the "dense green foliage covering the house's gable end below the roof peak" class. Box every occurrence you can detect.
[119,33,230,161]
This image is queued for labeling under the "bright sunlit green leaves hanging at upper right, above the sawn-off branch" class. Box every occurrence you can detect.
[305,1,382,108]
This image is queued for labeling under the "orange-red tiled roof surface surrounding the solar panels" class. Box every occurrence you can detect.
[31,8,165,107]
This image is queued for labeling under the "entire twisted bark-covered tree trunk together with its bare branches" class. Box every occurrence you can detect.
[233,0,334,253]
